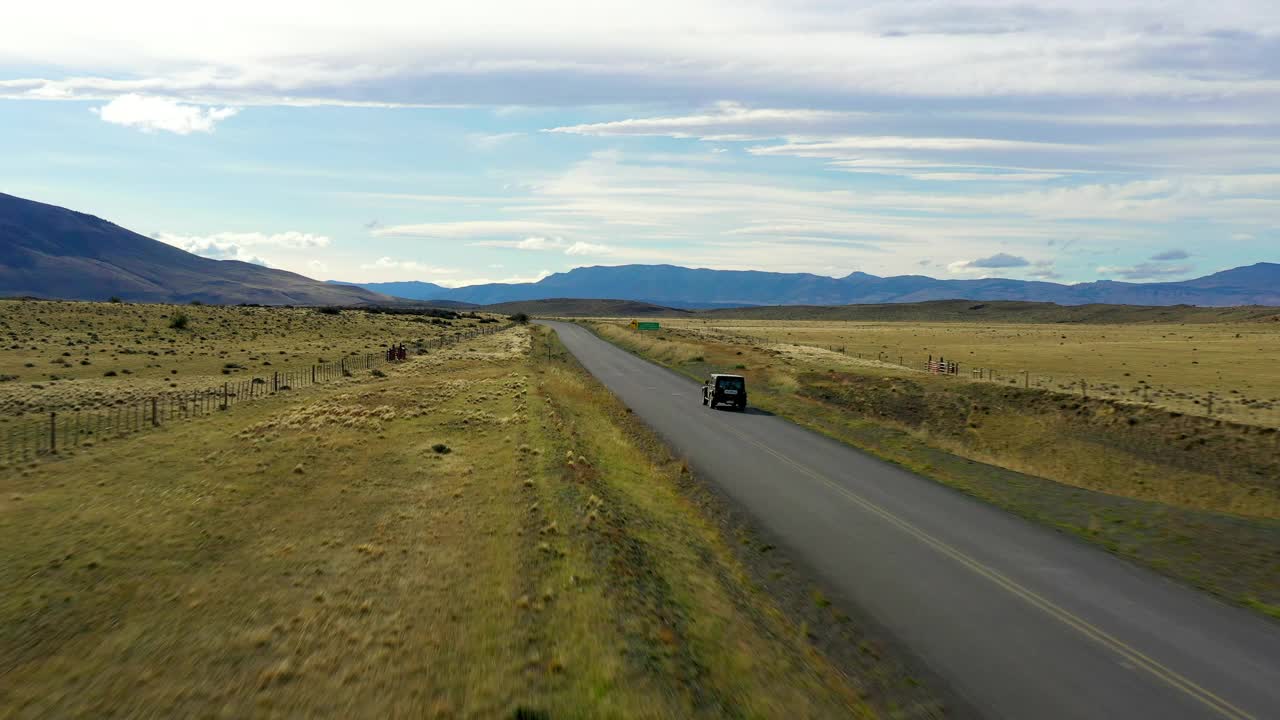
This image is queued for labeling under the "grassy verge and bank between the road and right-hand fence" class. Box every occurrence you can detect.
[590,322,1280,616]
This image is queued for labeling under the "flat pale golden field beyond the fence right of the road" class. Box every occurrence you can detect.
[640,318,1280,427]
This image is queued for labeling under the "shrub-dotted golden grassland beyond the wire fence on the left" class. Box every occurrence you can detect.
[0,300,494,421]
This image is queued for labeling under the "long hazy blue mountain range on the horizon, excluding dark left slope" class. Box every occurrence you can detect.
[340,263,1280,309]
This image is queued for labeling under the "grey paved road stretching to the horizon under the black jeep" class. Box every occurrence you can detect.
[548,323,1280,720]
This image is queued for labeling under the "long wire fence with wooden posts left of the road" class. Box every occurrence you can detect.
[0,324,515,462]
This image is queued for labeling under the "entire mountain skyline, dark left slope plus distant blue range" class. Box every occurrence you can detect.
[0,193,1280,309]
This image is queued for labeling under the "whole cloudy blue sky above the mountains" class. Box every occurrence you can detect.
[0,0,1280,287]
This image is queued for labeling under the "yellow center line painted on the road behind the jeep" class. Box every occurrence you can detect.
[723,423,1256,720]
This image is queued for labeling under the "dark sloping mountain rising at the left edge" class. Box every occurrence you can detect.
[0,193,394,305]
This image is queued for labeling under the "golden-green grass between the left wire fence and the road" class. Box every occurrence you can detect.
[0,322,933,717]
